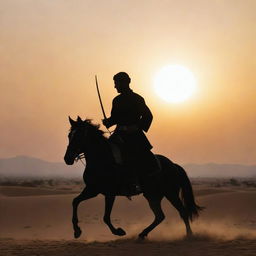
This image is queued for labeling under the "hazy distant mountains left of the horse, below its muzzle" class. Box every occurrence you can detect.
[0,156,84,178]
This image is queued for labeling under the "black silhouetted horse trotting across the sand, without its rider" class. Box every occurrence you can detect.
[64,117,202,239]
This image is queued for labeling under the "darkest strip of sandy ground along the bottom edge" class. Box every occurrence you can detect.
[0,237,256,256]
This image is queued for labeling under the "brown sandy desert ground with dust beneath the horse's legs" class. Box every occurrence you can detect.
[0,186,256,256]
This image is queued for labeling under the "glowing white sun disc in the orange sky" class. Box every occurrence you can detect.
[154,65,196,103]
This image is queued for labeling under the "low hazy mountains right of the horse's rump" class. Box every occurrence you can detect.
[183,163,256,178]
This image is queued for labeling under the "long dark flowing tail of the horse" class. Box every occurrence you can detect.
[176,165,204,221]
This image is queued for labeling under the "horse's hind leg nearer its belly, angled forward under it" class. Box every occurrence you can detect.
[139,196,165,239]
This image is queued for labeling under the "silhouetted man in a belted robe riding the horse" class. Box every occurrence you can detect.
[103,72,159,191]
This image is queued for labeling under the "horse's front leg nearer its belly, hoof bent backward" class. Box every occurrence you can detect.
[103,196,126,236]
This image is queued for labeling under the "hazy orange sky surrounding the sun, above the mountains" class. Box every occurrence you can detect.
[0,0,256,164]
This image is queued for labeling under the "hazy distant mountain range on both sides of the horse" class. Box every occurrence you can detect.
[0,156,256,178]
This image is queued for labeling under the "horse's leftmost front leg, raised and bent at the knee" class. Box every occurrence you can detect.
[72,188,98,238]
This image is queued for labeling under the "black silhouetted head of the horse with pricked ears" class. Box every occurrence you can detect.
[64,116,89,165]
